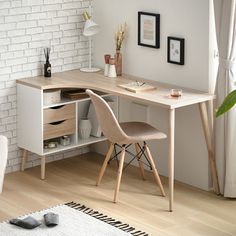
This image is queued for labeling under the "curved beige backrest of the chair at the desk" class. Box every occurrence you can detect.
[86,89,128,143]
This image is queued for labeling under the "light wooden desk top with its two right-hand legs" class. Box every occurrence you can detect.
[17,70,219,211]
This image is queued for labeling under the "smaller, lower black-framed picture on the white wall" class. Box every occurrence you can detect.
[167,37,184,65]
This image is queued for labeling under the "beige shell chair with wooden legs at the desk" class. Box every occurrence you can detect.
[86,89,167,202]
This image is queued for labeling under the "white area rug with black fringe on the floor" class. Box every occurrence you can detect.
[0,202,148,236]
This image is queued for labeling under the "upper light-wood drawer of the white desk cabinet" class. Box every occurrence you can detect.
[43,103,75,124]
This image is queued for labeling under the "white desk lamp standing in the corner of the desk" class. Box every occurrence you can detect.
[80,1,100,72]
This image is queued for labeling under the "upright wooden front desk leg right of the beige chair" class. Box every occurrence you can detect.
[169,109,175,211]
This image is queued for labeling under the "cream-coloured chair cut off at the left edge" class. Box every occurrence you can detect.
[0,135,8,193]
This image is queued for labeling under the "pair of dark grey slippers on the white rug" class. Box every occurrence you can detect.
[9,212,59,229]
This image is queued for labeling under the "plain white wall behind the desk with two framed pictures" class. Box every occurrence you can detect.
[94,0,216,189]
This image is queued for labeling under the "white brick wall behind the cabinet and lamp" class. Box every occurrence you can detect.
[0,0,89,172]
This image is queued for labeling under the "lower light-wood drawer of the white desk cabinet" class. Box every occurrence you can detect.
[43,118,76,140]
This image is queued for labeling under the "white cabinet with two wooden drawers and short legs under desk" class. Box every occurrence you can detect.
[17,83,118,179]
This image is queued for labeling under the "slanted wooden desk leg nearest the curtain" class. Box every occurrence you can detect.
[199,102,220,194]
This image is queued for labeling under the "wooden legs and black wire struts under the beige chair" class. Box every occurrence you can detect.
[97,142,165,203]
